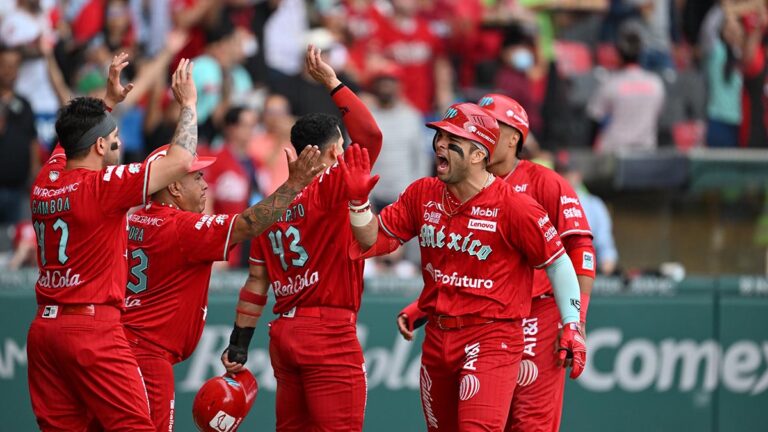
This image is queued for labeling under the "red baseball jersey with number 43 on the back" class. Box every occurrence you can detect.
[250,165,363,313]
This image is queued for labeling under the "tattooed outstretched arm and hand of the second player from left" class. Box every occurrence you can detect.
[230,146,326,243]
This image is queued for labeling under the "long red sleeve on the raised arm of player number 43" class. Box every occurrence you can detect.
[331,84,382,165]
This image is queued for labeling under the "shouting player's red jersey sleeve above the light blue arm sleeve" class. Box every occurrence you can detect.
[507,194,565,268]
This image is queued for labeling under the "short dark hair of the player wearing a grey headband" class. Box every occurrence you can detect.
[56,96,107,160]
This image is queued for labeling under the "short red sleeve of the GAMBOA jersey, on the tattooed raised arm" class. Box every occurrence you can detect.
[96,162,151,213]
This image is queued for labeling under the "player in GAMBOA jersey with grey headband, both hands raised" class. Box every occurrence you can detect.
[27,54,204,431]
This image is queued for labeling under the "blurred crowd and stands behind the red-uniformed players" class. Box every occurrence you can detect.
[0,0,768,277]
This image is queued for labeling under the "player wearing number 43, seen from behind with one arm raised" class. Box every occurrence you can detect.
[222,46,382,432]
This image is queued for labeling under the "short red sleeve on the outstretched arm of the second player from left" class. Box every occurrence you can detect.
[176,213,238,262]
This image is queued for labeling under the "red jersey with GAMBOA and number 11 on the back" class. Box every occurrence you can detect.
[30,148,149,307]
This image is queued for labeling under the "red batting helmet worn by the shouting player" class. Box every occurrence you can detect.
[427,102,499,157]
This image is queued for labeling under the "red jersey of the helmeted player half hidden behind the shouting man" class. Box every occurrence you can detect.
[504,160,595,297]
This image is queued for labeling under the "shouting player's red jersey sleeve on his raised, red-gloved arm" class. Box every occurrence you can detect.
[379,180,424,243]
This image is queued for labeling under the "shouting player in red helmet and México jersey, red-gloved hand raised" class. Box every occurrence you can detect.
[341,103,585,432]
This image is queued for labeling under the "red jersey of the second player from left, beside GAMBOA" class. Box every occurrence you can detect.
[123,203,237,360]
